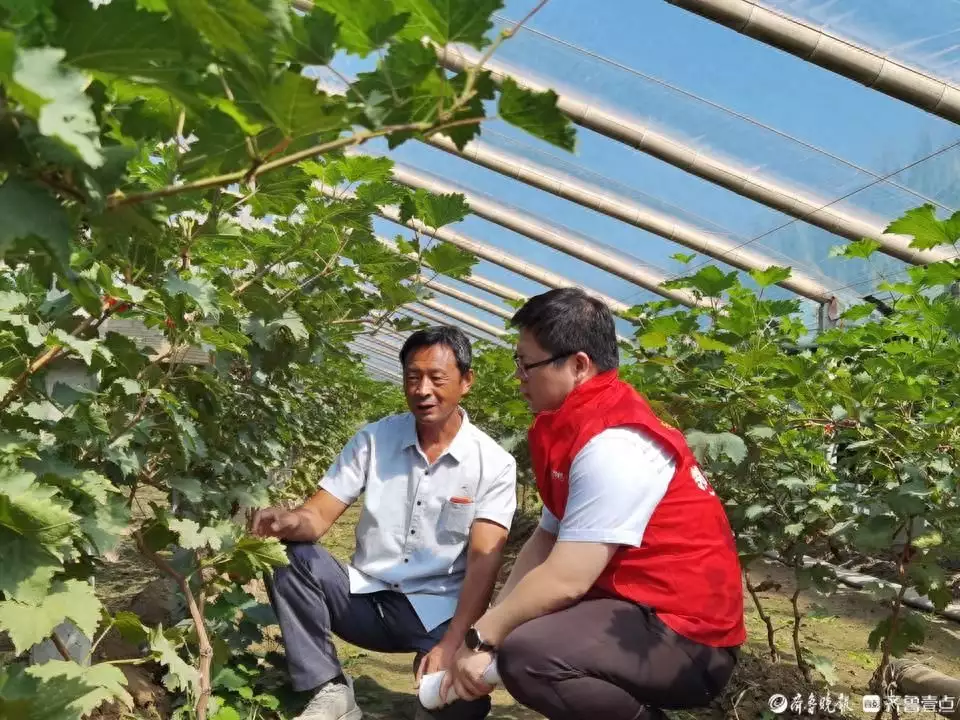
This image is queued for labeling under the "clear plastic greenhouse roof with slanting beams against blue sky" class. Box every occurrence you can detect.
[315,0,960,377]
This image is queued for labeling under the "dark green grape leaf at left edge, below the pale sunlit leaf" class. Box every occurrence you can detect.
[0,176,70,266]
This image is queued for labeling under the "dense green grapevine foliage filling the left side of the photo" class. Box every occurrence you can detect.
[0,0,573,719]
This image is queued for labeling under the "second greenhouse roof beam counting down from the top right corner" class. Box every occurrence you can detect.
[437,46,954,265]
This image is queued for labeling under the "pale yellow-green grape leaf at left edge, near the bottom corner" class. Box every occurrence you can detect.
[0,580,101,653]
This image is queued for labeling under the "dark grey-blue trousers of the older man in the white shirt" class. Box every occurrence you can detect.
[270,543,490,720]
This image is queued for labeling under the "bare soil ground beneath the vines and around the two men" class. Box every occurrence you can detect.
[86,498,960,720]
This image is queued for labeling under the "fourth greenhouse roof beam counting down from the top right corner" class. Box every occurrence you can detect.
[393,163,709,307]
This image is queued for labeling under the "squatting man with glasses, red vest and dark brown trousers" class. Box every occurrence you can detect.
[441,288,746,720]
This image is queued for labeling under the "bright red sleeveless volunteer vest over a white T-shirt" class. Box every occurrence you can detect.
[528,370,746,647]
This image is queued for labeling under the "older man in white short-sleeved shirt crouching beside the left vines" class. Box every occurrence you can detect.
[252,327,516,720]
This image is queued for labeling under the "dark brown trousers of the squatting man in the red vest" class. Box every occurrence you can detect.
[497,599,737,720]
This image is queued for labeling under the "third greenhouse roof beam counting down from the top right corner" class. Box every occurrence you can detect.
[428,135,833,303]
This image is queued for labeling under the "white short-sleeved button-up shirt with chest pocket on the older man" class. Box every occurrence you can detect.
[320,409,517,631]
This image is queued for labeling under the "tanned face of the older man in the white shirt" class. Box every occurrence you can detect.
[403,345,473,425]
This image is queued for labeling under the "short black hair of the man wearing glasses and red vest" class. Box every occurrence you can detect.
[510,288,620,372]
